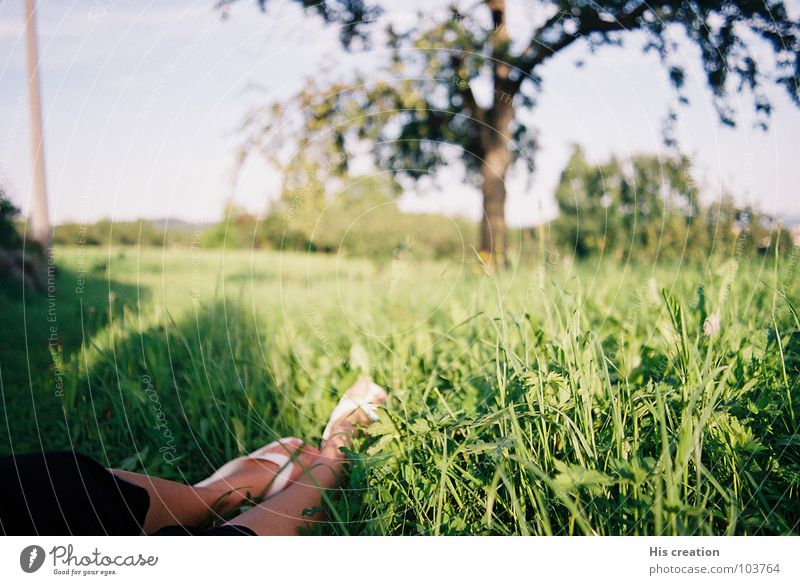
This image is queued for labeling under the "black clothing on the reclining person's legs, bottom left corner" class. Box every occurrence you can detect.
[0,451,254,536]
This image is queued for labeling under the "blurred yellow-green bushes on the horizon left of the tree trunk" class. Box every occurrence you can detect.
[53,177,477,259]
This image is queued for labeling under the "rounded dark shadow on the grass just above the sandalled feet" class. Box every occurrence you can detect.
[49,301,317,483]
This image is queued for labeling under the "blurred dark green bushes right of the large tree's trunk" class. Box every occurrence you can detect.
[544,147,793,262]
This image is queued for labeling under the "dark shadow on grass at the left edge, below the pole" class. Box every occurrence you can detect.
[0,268,148,455]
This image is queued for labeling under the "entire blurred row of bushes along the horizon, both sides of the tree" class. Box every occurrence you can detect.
[10,147,793,262]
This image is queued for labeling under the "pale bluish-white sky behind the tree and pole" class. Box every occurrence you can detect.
[0,0,800,226]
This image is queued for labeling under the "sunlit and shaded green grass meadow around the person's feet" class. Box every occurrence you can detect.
[0,248,800,535]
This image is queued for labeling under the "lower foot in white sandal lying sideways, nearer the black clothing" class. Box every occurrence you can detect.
[194,437,320,514]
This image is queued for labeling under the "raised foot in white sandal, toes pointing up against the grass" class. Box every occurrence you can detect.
[321,376,387,458]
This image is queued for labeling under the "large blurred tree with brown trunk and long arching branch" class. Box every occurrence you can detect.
[220,0,800,263]
